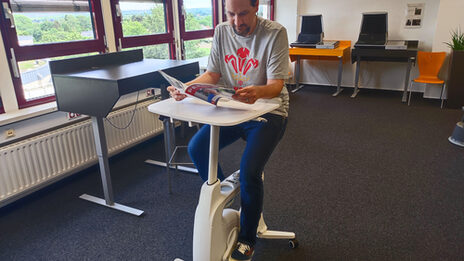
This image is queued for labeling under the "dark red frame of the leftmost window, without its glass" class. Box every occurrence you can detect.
[0,0,107,109]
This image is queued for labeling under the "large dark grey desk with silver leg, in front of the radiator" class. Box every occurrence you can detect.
[50,49,199,216]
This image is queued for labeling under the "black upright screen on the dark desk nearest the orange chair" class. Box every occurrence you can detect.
[356,12,388,45]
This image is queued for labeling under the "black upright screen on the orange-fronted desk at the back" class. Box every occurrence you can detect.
[290,15,324,48]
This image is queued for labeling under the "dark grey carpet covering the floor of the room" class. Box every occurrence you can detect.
[0,86,464,261]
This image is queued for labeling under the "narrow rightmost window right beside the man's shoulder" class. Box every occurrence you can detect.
[178,0,218,59]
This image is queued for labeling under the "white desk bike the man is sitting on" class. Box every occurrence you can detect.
[148,98,295,261]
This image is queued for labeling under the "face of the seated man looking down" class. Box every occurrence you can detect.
[226,0,258,36]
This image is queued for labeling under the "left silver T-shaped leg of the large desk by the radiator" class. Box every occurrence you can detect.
[79,116,143,216]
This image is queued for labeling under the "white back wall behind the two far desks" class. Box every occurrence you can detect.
[276,0,444,95]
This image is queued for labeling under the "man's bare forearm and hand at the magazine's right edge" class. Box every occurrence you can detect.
[233,79,284,104]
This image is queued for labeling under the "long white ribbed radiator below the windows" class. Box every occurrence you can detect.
[0,100,163,207]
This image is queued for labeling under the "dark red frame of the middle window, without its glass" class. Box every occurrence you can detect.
[110,0,176,59]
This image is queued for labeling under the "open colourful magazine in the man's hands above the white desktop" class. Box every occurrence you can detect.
[159,71,237,105]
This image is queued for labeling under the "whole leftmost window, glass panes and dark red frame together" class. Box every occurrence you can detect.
[0,0,106,108]
